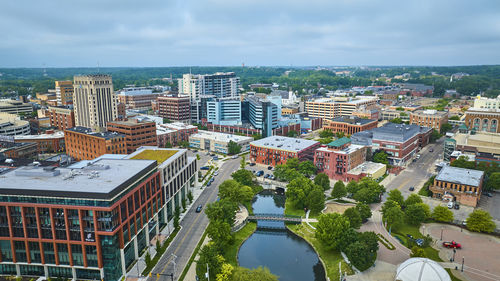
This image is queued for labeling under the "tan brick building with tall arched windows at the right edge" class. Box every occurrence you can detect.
[464,108,500,133]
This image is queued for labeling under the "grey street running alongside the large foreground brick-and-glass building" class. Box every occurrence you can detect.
[147,158,240,281]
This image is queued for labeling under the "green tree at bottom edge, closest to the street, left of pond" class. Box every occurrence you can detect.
[196,242,224,281]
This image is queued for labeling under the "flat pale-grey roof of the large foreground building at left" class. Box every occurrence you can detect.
[0,159,156,200]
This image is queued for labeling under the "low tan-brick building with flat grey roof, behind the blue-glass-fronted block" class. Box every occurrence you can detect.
[323,116,378,136]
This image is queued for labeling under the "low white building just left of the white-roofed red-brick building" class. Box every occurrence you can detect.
[189,130,253,154]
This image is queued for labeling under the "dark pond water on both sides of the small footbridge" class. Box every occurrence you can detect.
[238,191,325,281]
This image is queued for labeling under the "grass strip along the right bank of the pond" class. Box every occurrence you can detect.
[288,224,354,280]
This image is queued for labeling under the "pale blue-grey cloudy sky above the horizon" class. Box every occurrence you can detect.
[0,0,500,67]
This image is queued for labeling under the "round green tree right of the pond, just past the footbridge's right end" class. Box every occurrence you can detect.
[315,213,350,250]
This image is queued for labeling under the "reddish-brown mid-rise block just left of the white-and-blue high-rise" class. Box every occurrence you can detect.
[157,95,191,123]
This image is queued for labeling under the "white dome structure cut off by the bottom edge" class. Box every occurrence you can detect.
[394,258,451,281]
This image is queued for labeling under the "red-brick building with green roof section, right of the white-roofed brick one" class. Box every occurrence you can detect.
[314,138,366,181]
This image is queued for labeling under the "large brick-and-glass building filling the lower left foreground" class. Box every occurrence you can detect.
[0,150,196,281]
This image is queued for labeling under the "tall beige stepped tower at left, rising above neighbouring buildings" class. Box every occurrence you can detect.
[73,74,118,131]
